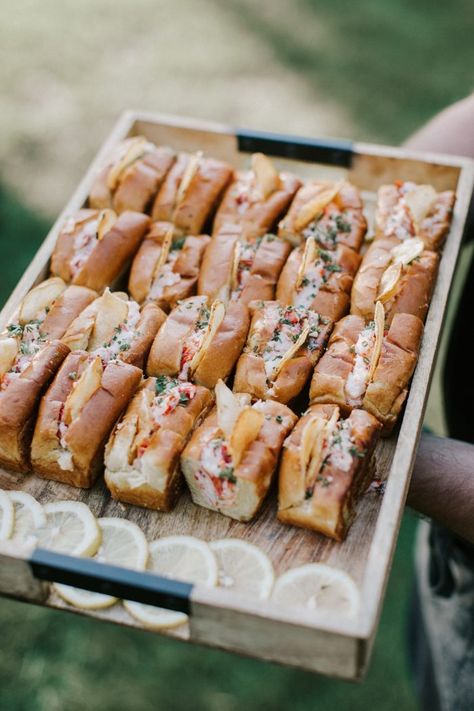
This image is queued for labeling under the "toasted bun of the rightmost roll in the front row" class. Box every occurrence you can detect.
[278,405,381,541]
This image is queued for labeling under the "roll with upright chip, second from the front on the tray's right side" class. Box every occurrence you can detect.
[310,311,423,434]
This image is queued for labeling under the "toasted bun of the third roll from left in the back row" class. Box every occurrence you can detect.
[213,171,301,238]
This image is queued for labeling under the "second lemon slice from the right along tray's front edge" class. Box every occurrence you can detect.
[209,538,275,600]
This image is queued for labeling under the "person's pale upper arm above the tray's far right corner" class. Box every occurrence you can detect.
[404,94,474,158]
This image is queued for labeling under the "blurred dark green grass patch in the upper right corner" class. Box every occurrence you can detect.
[232,0,474,143]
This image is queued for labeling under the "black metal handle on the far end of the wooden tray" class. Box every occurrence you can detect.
[235,129,354,168]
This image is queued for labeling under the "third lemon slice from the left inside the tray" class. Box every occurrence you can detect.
[36,501,101,556]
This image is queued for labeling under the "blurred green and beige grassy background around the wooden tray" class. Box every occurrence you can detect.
[0,0,474,711]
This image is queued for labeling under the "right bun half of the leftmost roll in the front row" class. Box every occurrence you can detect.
[0,341,69,472]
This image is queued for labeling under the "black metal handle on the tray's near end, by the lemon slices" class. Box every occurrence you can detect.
[29,548,193,615]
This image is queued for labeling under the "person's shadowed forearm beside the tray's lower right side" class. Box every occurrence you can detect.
[407,434,474,544]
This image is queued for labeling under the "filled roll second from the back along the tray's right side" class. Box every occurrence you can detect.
[351,237,439,324]
